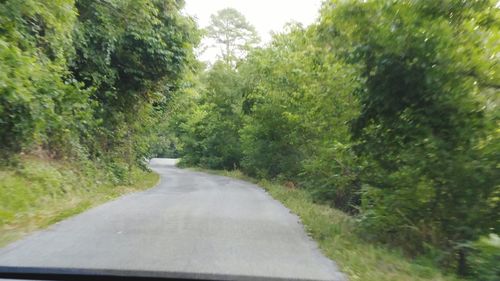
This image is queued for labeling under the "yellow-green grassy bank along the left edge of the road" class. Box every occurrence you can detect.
[0,157,159,246]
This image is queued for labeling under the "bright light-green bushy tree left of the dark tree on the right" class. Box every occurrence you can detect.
[239,25,359,211]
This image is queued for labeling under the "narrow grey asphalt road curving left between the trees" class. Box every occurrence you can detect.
[0,159,346,280]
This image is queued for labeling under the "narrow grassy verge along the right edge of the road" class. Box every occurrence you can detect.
[190,169,459,281]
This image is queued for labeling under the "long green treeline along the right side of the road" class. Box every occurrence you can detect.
[168,0,500,280]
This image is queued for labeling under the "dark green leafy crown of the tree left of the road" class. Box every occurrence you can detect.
[74,0,194,111]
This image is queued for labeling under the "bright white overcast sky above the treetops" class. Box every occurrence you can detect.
[184,0,323,62]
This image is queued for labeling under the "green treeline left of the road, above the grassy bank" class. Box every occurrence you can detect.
[0,0,198,180]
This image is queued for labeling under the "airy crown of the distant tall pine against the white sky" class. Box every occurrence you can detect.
[207,8,260,67]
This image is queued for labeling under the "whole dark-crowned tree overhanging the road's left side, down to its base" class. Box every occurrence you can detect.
[72,0,197,167]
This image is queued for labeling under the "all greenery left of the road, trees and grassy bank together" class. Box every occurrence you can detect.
[0,0,198,241]
